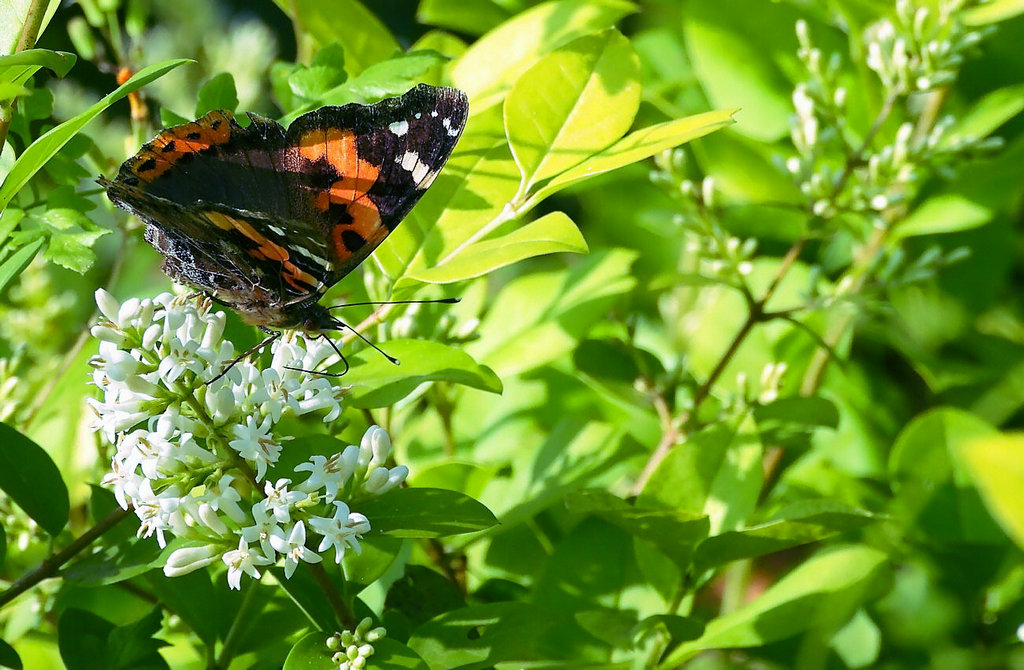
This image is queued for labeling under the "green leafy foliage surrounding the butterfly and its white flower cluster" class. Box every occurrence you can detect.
[0,0,1024,669]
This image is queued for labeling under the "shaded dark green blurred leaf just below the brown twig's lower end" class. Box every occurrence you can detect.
[565,491,710,566]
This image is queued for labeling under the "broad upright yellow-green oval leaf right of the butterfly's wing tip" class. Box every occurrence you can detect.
[505,30,640,193]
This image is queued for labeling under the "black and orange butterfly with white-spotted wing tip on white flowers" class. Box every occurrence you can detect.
[99,84,469,333]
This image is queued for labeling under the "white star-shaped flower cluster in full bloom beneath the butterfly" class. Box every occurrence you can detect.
[91,290,409,588]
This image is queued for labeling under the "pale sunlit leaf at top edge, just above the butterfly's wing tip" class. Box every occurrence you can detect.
[451,0,636,114]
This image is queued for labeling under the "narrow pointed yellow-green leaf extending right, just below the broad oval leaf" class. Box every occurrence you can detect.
[520,110,735,211]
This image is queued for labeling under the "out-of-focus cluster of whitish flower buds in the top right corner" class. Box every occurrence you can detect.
[781,6,1001,225]
